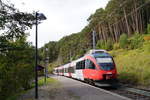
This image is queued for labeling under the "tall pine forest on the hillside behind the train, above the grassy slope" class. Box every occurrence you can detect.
[39,0,150,65]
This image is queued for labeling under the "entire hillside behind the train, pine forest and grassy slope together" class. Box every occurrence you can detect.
[39,0,150,85]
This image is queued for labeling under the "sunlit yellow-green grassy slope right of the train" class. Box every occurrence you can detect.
[110,41,150,86]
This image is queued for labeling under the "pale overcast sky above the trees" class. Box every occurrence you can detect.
[7,0,109,47]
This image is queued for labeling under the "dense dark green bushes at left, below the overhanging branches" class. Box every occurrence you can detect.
[0,40,34,100]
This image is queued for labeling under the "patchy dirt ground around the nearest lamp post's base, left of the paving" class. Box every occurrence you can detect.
[18,83,80,100]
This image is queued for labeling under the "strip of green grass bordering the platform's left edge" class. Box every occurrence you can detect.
[7,77,58,100]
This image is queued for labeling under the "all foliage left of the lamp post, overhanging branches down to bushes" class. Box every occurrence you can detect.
[0,1,34,100]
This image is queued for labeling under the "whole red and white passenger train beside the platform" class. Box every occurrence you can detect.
[54,50,117,86]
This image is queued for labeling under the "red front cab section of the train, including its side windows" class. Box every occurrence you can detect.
[83,50,117,84]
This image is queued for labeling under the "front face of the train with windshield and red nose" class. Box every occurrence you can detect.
[92,52,117,85]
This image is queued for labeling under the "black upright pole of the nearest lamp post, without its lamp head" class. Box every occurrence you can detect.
[35,12,38,99]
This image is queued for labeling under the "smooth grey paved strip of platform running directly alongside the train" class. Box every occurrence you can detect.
[53,76,128,100]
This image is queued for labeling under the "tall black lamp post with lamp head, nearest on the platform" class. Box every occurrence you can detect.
[35,12,46,99]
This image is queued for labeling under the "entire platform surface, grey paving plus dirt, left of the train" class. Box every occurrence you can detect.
[18,75,127,100]
